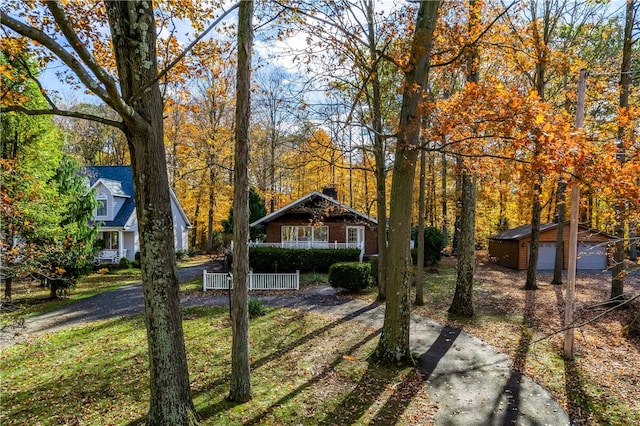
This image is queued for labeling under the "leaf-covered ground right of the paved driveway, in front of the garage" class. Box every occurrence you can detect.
[414,256,640,425]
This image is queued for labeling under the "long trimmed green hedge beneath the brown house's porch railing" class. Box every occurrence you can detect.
[249,247,360,273]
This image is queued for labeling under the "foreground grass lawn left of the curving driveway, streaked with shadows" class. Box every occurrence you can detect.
[0,308,433,426]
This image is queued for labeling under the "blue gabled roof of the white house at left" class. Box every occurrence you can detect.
[81,166,136,228]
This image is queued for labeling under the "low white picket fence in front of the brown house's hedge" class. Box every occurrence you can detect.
[202,270,300,291]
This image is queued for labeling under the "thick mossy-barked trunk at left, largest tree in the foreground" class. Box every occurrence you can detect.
[105,1,197,425]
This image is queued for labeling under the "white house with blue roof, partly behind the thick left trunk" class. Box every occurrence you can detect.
[83,166,191,262]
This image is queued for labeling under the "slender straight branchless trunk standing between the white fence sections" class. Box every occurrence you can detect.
[229,0,253,402]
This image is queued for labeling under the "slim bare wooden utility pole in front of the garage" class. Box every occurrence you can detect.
[564,69,587,359]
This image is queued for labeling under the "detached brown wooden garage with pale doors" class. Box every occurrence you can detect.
[489,223,613,270]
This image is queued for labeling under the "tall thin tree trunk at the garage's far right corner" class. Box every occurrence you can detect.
[611,0,634,300]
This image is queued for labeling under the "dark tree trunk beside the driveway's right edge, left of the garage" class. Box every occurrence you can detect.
[449,0,482,317]
